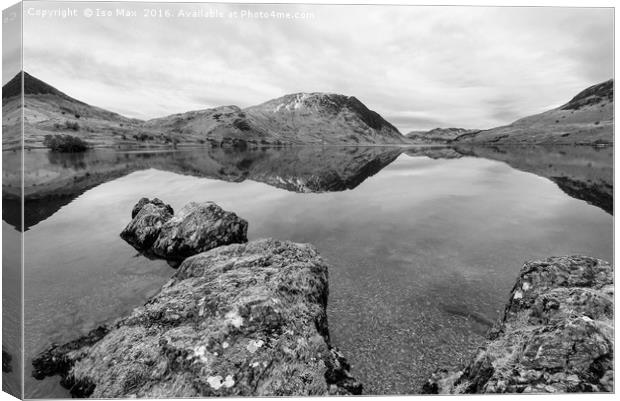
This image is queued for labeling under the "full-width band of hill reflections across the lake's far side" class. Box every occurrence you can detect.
[2,146,613,229]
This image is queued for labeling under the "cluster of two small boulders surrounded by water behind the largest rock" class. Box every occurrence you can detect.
[121,198,248,261]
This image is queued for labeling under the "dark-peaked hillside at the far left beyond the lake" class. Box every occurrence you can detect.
[2,72,141,150]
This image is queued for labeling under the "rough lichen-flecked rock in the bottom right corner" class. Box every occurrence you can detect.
[423,256,614,393]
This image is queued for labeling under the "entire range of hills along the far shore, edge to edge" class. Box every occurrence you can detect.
[2,71,614,150]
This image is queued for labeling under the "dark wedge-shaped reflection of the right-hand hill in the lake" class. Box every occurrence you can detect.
[457,146,614,214]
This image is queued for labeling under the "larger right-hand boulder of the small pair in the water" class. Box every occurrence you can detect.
[153,202,248,260]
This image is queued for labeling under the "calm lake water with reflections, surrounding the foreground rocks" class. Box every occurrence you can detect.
[3,147,613,398]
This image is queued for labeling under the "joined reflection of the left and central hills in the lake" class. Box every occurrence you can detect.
[2,147,402,229]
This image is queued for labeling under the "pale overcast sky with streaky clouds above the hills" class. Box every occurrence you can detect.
[14,2,613,133]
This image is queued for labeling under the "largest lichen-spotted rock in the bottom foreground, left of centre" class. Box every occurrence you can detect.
[33,239,361,398]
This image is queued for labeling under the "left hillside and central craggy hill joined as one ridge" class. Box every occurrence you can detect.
[2,72,407,150]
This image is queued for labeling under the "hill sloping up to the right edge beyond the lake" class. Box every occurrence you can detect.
[454,79,614,145]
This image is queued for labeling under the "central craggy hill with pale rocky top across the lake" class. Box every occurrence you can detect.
[144,93,406,146]
